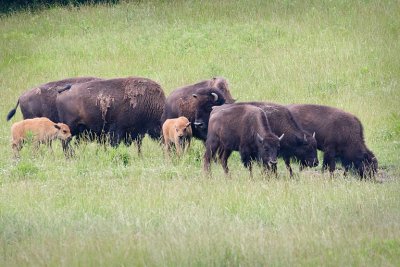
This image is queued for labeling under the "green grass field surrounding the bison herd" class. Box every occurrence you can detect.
[0,0,400,266]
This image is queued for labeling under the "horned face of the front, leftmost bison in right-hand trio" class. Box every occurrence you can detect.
[256,133,284,165]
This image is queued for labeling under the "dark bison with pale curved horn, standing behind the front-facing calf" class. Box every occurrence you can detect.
[161,78,234,140]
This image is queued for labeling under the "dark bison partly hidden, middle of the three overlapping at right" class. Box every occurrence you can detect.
[238,102,318,176]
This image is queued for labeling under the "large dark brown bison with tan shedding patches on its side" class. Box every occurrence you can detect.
[56,77,165,153]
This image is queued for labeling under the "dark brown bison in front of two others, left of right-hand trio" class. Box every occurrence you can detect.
[204,104,284,176]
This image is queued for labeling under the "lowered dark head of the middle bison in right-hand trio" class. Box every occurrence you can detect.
[293,133,319,167]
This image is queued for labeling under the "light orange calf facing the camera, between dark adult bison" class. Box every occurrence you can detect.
[162,117,192,155]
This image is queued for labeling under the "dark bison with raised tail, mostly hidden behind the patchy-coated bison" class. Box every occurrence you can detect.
[7,77,100,122]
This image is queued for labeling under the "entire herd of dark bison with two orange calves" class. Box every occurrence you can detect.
[7,77,378,178]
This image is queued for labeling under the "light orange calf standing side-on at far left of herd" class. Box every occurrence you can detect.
[11,117,71,157]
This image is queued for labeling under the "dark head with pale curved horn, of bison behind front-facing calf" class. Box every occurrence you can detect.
[193,88,225,140]
